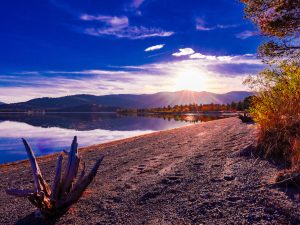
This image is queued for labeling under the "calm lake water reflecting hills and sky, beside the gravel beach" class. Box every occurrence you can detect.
[0,113,232,164]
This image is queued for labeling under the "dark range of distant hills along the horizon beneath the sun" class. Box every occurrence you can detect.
[0,91,253,112]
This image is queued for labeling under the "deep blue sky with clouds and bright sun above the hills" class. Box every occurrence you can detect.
[0,0,262,103]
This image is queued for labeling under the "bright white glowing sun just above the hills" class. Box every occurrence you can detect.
[173,67,209,91]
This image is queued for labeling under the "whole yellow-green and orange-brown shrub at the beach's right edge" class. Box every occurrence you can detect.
[246,61,300,171]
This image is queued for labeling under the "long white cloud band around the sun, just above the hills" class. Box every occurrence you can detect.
[0,50,262,103]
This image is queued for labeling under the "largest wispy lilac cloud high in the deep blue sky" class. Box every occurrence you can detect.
[80,14,174,40]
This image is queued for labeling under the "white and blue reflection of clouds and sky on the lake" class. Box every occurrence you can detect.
[0,121,152,163]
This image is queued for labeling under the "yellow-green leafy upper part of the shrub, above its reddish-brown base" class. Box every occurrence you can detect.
[248,62,300,127]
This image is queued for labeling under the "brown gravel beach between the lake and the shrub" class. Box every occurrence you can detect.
[0,118,300,224]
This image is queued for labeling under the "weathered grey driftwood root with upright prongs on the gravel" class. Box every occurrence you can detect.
[6,137,103,218]
